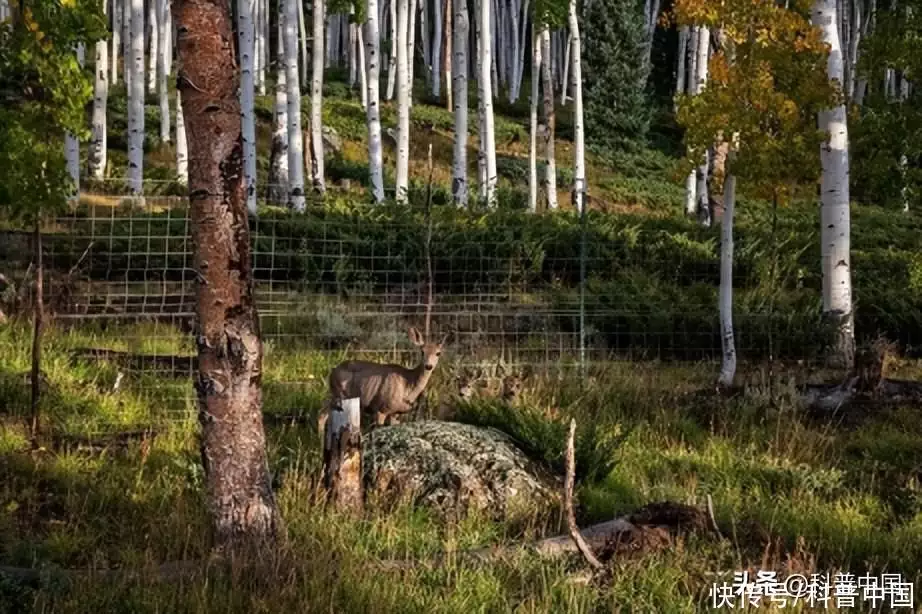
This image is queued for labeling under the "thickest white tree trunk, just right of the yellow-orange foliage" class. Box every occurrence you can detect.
[812,0,855,369]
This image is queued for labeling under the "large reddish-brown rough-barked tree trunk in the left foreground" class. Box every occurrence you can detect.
[177,0,281,546]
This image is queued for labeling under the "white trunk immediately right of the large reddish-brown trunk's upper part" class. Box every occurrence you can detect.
[237,0,256,216]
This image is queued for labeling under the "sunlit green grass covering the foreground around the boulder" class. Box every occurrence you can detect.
[0,325,922,613]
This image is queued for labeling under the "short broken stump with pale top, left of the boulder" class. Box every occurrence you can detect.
[323,398,364,513]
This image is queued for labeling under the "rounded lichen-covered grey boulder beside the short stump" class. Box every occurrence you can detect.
[363,420,560,519]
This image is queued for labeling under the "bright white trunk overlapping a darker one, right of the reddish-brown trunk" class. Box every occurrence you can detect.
[283,0,305,212]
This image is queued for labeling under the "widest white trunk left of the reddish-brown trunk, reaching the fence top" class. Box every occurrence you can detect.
[125,0,144,196]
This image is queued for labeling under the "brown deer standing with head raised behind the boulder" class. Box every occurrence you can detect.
[329,327,448,426]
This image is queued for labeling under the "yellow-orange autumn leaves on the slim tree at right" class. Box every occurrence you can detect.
[672,0,839,199]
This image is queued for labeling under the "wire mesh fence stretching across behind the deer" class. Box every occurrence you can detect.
[0,180,832,434]
